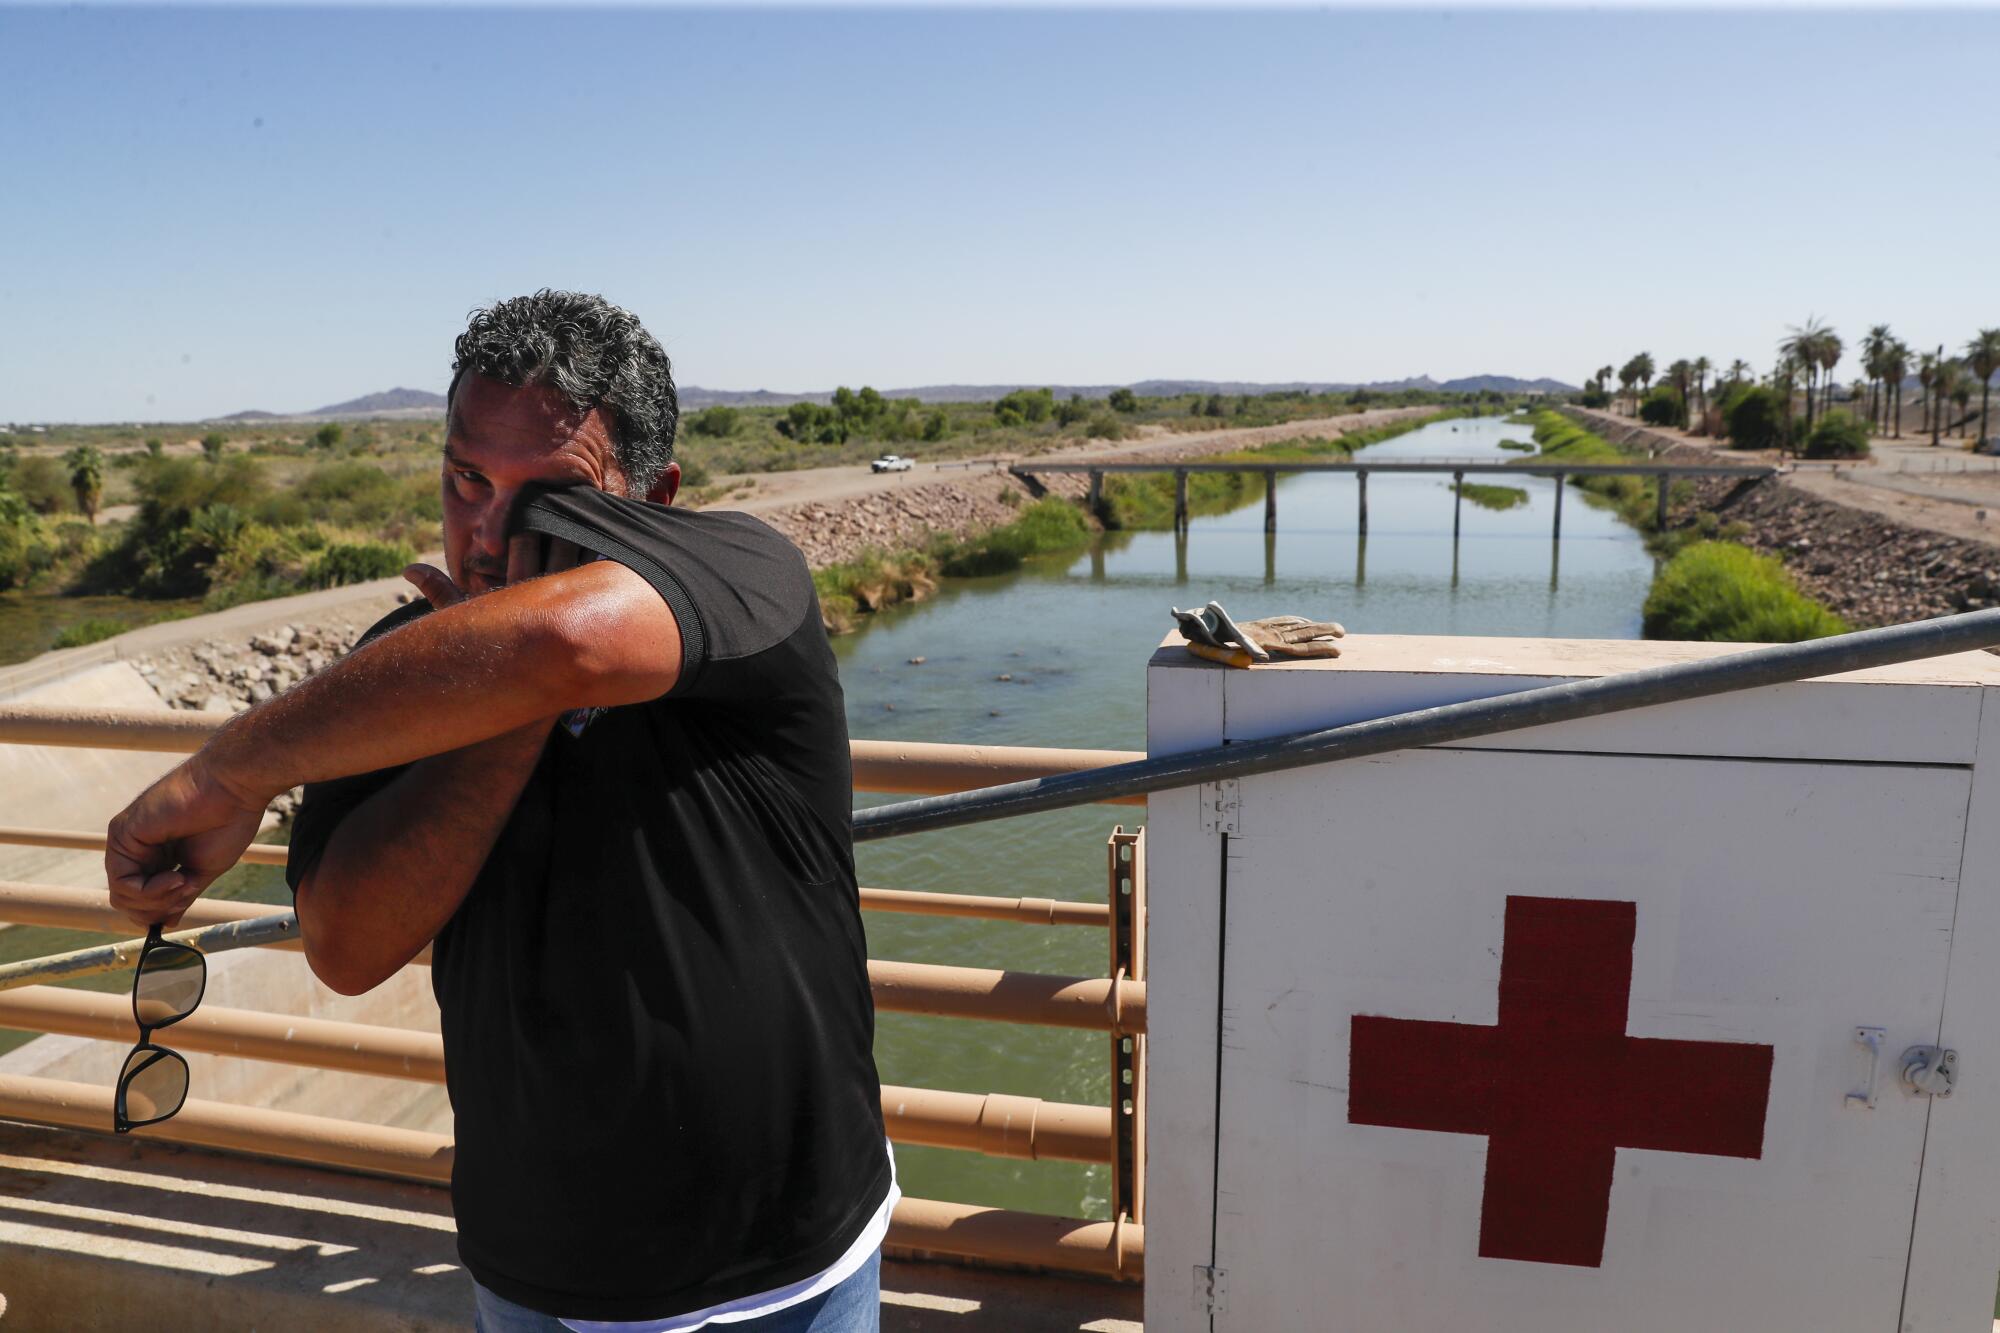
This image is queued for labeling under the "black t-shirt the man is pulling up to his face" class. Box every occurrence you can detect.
[286,488,890,1319]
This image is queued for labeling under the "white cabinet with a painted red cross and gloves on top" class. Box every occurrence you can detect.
[1146,638,2000,1333]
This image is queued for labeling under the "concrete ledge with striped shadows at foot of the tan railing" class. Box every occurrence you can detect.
[0,1121,1140,1333]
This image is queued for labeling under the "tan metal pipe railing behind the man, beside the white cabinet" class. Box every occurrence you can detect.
[0,720,1146,1279]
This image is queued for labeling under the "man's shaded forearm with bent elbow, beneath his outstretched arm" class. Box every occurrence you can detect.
[298,719,550,995]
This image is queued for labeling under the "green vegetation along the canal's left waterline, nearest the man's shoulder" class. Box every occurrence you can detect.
[812,492,1092,634]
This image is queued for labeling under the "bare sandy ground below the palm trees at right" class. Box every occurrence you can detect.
[1568,412,2000,544]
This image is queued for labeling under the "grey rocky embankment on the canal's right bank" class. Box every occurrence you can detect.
[1572,412,2000,628]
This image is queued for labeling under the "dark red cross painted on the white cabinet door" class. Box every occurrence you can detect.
[1348,897,1772,1269]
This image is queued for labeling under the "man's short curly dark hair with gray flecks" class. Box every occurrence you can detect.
[446,288,680,494]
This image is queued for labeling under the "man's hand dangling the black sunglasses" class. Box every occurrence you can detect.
[104,755,268,927]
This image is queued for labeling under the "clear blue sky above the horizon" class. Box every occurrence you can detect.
[0,6,2000,420]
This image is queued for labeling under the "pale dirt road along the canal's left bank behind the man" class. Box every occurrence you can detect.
[710,406,1438,514]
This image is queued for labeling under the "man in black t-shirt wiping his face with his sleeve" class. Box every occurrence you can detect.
[106,292,896,1333]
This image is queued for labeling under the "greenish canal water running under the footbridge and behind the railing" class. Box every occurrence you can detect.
[834,418,1654,1217]
